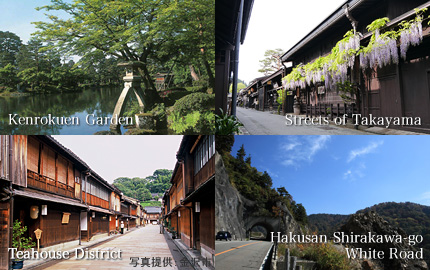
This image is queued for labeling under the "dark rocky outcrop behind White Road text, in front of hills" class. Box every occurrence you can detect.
[340,211,428,270]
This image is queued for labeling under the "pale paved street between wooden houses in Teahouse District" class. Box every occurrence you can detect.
[38,225,193,270]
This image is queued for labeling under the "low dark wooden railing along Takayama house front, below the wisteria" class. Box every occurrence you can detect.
[300,103,358,121]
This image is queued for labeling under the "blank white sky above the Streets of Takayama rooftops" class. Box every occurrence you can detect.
[239,0,346,84]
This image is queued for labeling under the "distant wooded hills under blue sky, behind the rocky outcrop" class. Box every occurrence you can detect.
[308,202,430,263]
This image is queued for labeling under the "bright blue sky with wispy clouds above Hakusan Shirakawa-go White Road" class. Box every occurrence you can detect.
[232,136,430,214]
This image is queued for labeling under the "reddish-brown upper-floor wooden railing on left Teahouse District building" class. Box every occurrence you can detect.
[27,170,75,198]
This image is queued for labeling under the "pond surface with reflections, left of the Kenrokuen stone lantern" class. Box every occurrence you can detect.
[0,87,125,135]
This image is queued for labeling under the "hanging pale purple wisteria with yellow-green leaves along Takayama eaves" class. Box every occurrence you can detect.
[282,8,430,90]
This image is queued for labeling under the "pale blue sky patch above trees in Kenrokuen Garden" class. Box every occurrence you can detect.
[0,0,68,43]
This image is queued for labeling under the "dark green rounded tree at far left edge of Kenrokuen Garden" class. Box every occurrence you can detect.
[0,31,22,67]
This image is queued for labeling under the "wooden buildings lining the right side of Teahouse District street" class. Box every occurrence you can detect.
[164,135,215,261]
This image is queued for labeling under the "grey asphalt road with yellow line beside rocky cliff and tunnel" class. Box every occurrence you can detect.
[215,240,272,270]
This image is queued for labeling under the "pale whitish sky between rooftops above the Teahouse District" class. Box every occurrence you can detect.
[52,135,182,183]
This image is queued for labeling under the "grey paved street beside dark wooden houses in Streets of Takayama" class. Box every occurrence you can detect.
[236,107,369,135]
